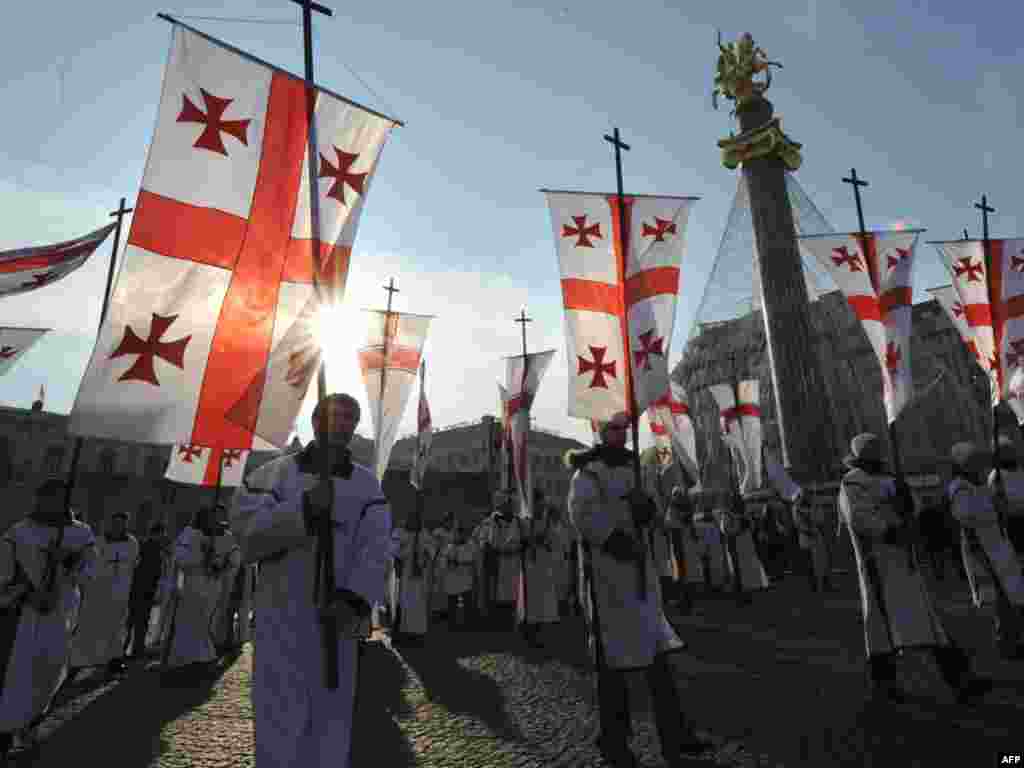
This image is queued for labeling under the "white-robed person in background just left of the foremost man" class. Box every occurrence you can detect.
[164,507,221,670]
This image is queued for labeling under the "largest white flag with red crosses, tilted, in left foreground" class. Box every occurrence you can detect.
[69,24,394,450]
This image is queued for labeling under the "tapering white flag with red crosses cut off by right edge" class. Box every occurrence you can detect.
[935,239,1024,410]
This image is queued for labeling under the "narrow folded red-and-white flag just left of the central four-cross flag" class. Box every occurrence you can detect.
[504,349,555,517]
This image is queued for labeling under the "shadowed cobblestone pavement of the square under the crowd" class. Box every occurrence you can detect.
[12,577,1024,768]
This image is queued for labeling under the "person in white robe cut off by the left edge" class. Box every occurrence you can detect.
[0,479,96,761]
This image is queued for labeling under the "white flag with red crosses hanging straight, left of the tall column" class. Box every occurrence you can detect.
[545,190,695,420]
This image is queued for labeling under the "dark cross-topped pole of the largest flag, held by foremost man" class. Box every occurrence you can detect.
[292,0,338,690]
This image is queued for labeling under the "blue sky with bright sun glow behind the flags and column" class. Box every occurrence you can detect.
[0,0,1024,441]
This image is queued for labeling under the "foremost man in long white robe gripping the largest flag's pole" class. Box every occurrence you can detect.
[230,394,392,768]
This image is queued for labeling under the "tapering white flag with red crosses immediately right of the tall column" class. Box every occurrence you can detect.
[800,229,922,424]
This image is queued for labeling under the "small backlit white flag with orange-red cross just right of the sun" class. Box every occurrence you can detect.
[359,309,433,479]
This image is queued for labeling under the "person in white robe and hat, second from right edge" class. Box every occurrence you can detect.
[948,442,1024,658]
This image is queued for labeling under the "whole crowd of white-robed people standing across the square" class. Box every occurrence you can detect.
[0,395,1024,768]
